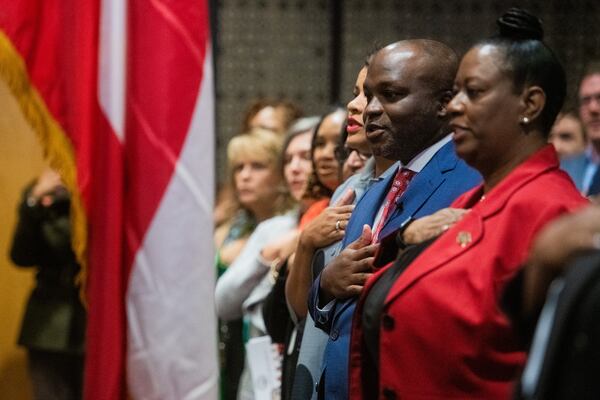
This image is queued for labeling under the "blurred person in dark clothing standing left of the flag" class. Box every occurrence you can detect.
[10,168,86,400]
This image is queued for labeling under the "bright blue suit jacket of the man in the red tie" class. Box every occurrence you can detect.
[309,142,481,399]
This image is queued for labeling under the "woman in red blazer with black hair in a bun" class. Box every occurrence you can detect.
[350,9,586,400]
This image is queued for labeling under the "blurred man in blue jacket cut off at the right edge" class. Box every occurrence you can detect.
[561,61,600,196]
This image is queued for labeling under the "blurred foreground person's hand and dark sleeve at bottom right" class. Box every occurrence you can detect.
[503,206,600,400]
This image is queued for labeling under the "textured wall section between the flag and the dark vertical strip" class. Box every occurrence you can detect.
[216,0,330,177]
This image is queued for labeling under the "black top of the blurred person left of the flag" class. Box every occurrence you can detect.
[10,184,86,355]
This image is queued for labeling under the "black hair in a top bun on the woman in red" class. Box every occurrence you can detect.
[479,8,567,137]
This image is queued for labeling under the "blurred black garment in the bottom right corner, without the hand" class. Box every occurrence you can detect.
[517,251,600,400]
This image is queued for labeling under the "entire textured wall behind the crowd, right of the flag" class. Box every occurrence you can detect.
[215,0,600,180]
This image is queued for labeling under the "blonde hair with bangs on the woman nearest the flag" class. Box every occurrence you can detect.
[227,128,293,214]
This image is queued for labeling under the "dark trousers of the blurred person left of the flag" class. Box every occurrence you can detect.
[27,350,83,400]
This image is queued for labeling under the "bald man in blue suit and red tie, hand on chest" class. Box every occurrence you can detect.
[309,39,481,399]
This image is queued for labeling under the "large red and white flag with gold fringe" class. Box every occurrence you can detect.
[0,0,218,400]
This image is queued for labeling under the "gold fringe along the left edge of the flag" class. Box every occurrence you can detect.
[0,31,87,304]
